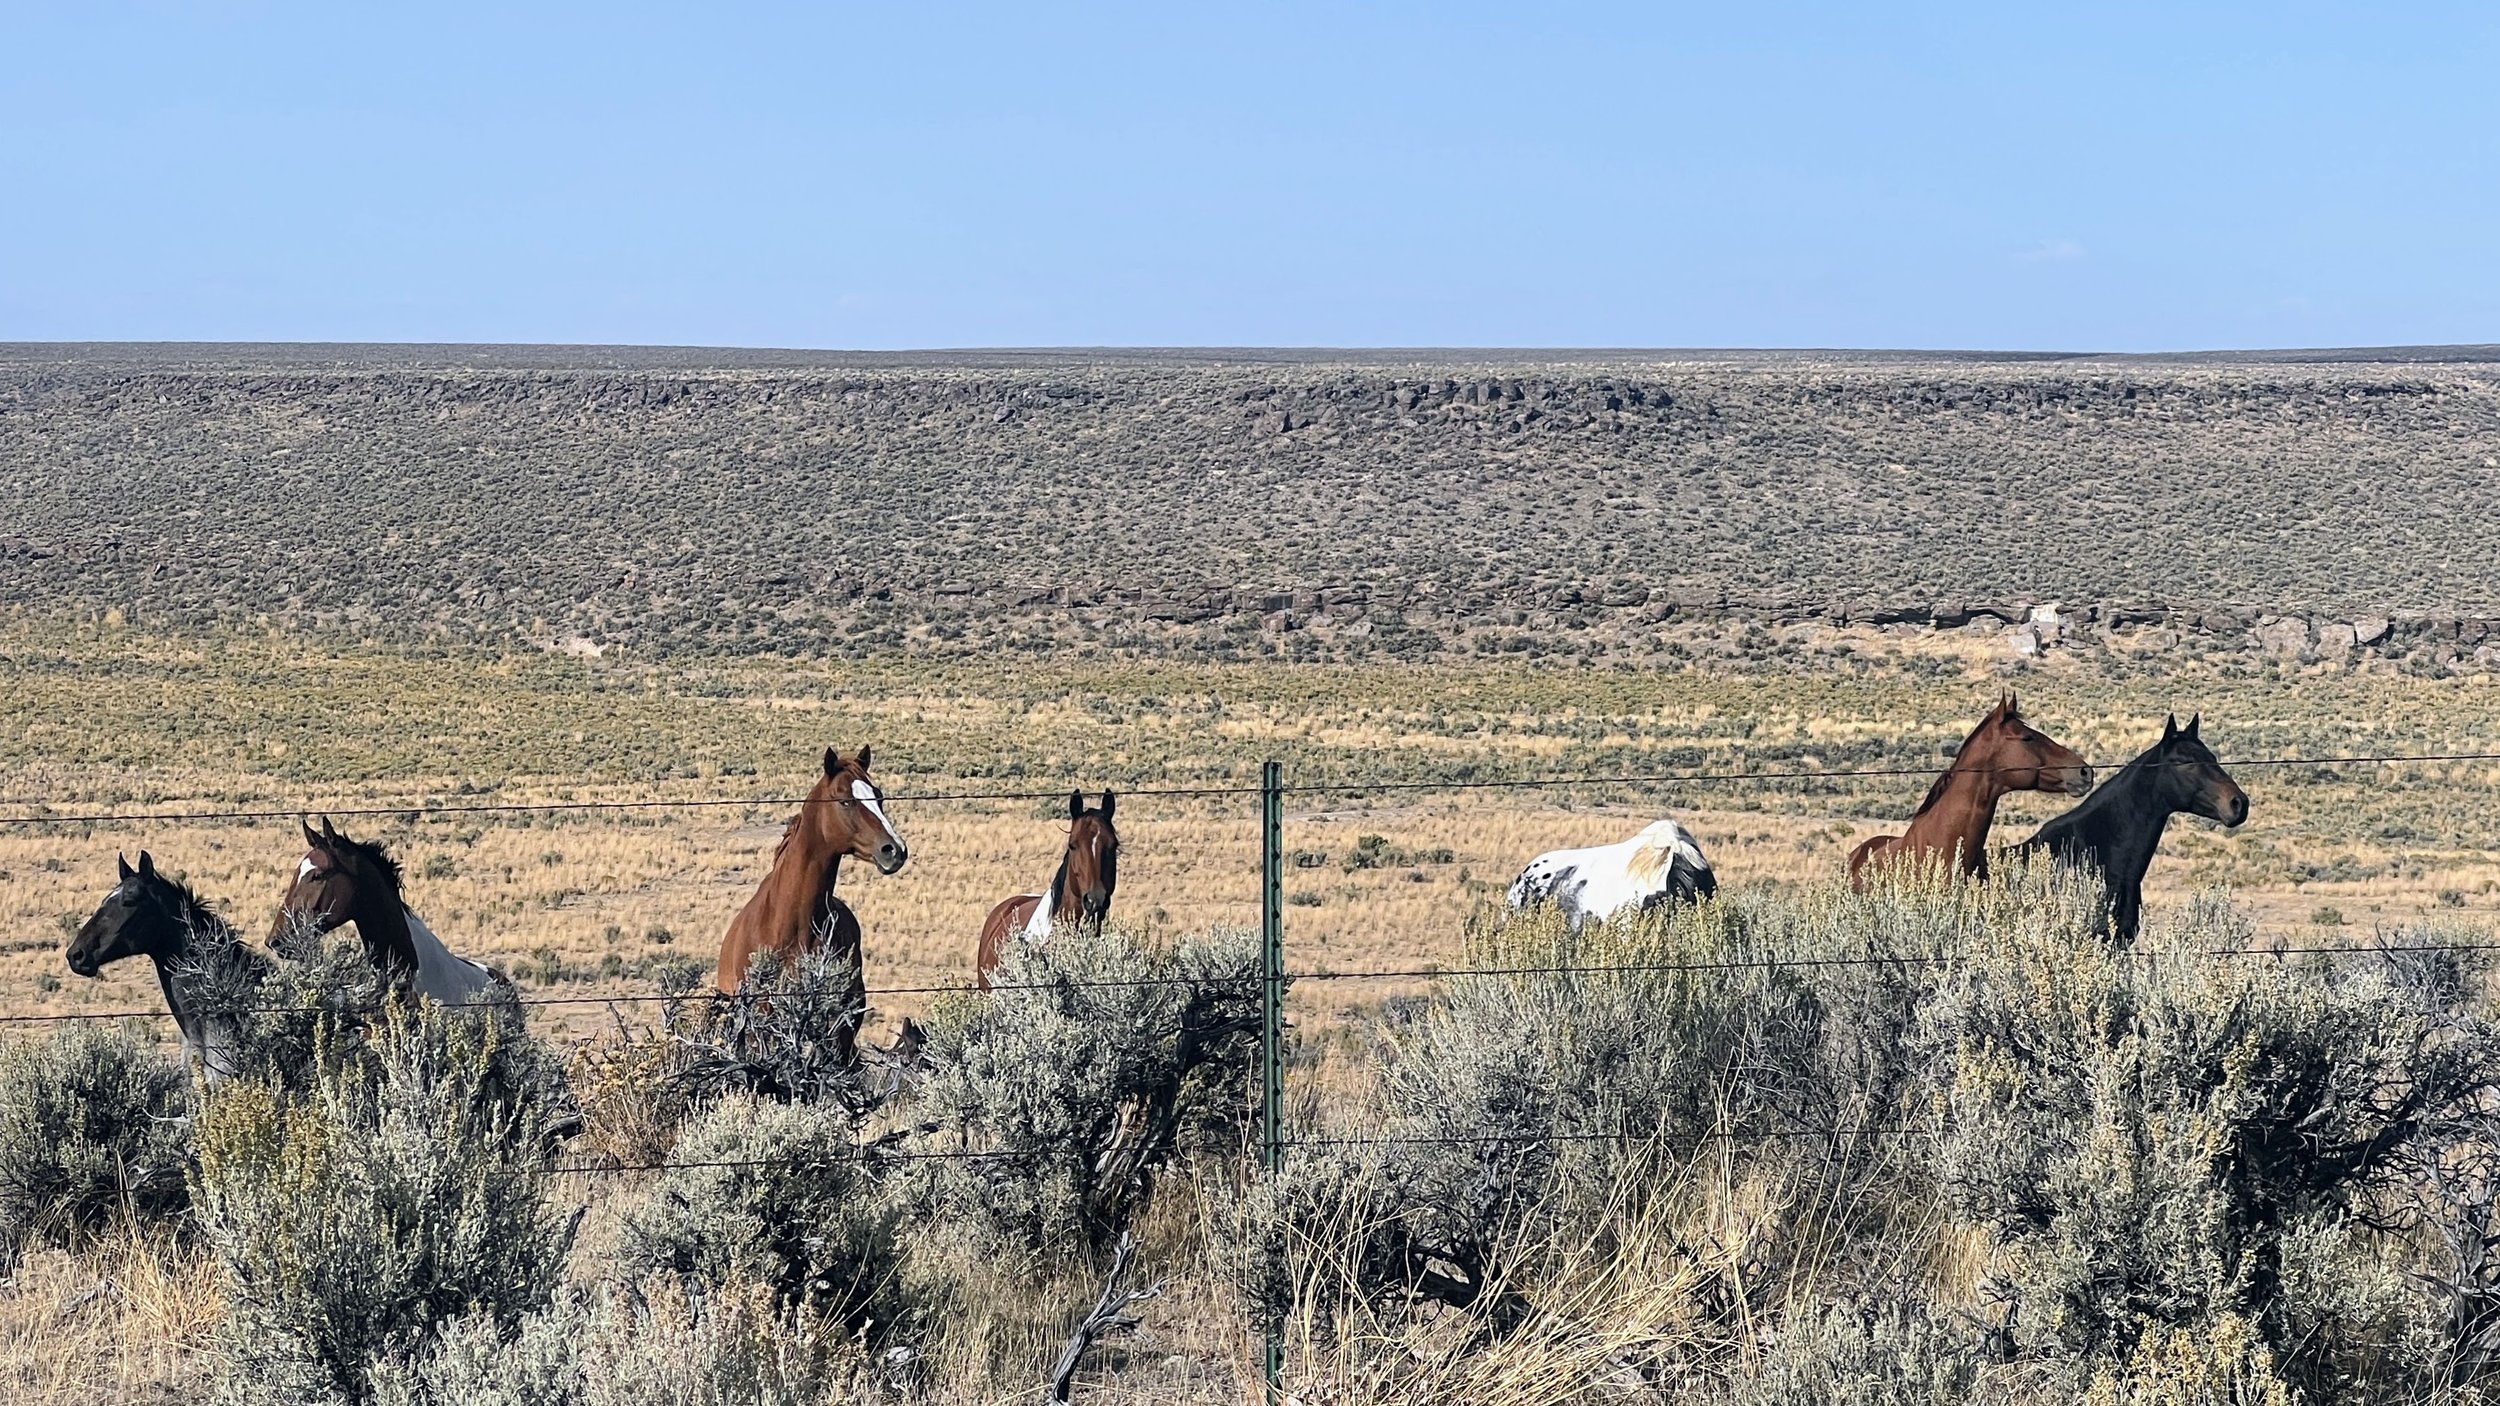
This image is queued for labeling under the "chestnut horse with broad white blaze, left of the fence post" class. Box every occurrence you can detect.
[713,748,910,1063]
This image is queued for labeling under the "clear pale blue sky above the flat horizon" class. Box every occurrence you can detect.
[0,0,2500,350]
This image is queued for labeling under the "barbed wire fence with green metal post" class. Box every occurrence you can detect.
[0,751,2500,1398]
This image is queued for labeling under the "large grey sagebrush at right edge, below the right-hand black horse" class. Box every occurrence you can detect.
[1923,885,2500,1391]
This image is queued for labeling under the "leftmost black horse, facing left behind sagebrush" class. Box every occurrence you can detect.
[65,851,270,1086]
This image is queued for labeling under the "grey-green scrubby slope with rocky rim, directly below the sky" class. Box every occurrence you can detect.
[0,348,2500,663]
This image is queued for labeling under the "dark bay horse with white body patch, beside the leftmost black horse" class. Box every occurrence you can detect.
[270,816,513,1006]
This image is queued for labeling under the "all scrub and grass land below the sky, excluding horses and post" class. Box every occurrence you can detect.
[0,348,2500,1406]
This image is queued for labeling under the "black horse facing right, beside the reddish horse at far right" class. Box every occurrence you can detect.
[2015,713,2248,943]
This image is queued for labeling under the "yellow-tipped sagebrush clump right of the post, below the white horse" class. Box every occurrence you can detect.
[1245,896,1893,1313]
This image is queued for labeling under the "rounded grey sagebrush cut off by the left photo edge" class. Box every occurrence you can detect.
[0,1021,190,1276]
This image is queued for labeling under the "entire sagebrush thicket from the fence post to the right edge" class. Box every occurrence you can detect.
[1250,866,2500,1403]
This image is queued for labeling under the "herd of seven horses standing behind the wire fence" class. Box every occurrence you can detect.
[68,695,2248,1081]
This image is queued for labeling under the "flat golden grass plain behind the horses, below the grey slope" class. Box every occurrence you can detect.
[0,625,2500,1031]
